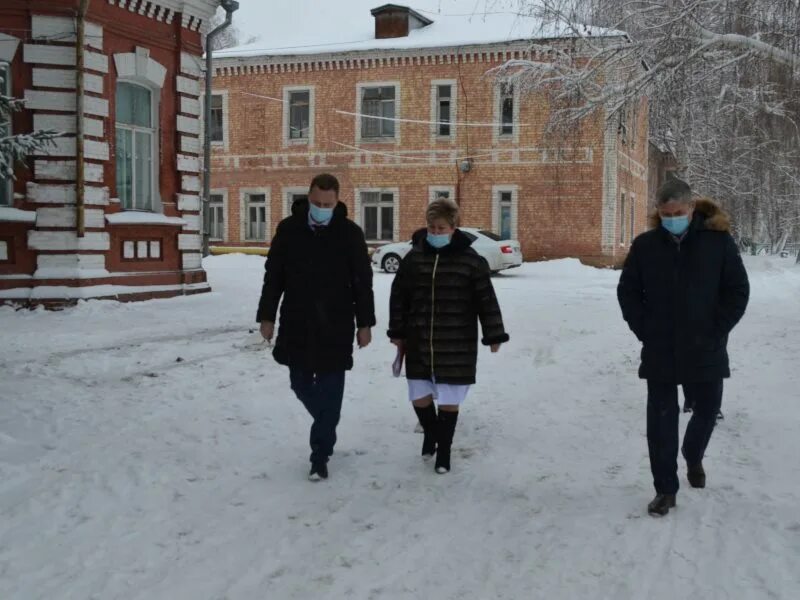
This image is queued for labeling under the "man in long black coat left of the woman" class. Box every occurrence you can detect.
[256,174,375,481]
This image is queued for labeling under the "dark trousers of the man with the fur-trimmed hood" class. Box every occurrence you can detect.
[647,379,722,494]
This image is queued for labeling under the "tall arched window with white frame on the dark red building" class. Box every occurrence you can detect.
[116,82,157,210]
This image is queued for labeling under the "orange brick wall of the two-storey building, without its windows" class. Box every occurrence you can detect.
[212,52,647,261]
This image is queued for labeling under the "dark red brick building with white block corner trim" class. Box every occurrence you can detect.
[0,0,219,304]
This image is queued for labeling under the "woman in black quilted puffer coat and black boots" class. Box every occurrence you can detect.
[388,199,509,473]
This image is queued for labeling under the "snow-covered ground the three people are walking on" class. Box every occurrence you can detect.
[0,256,800,600]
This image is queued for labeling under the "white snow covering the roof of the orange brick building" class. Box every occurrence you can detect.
[214,0,624,59]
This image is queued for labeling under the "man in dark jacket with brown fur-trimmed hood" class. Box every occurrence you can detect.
[617,179,750,515]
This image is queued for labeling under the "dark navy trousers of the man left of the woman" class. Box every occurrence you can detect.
[289,368,345,463]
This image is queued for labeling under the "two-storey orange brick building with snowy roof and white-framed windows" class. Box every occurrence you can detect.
[210,5,648,264]
